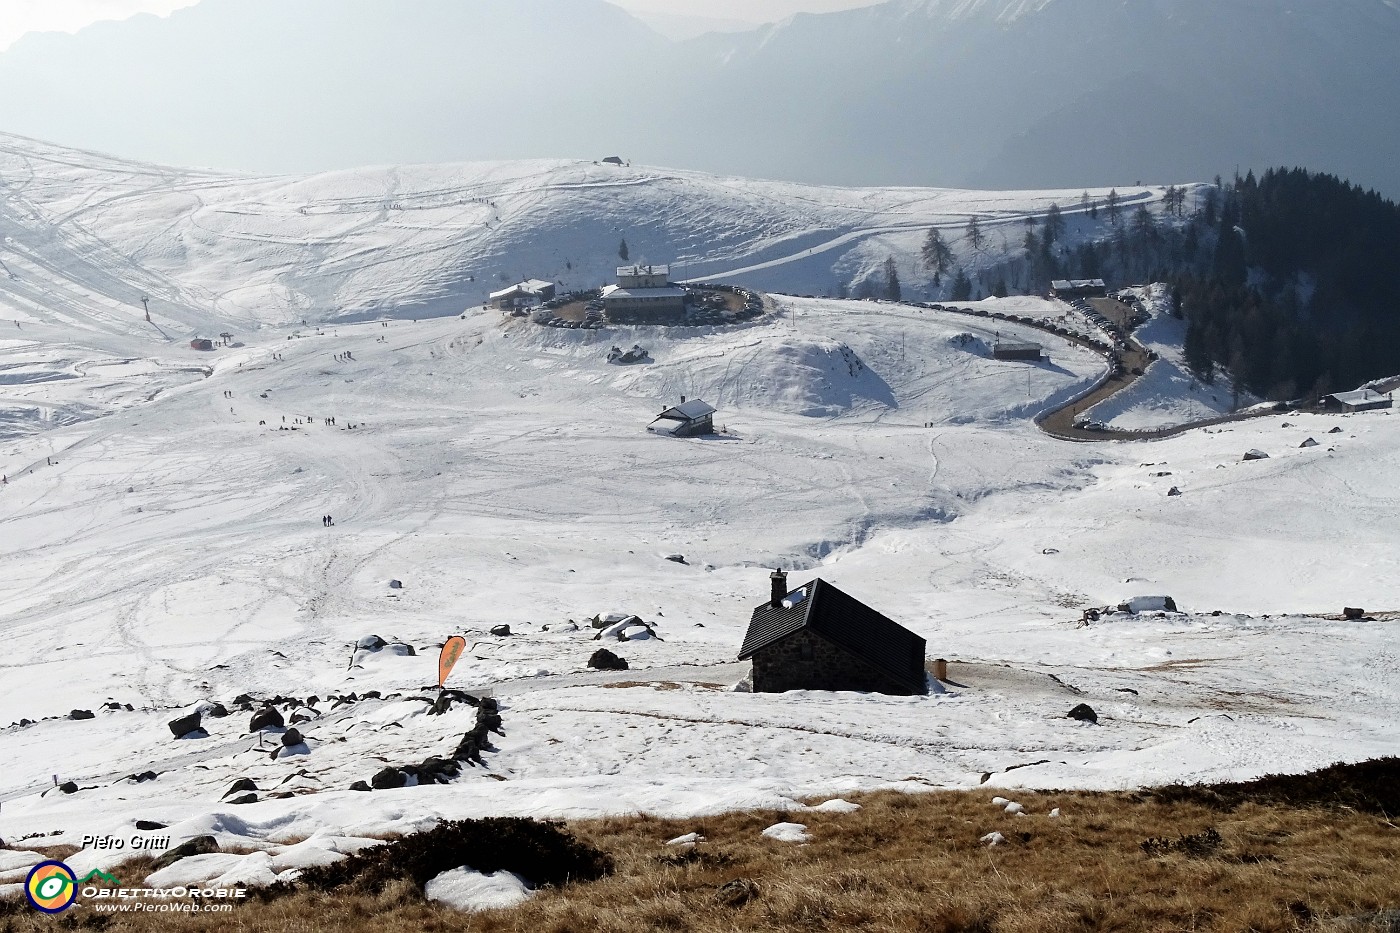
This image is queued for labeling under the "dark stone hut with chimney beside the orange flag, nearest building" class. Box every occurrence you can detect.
[739,570,928,696]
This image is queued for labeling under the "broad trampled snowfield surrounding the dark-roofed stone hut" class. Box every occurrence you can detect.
[0,136,1400,885]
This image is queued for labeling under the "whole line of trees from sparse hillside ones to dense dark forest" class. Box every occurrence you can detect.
[841,168,1400,399]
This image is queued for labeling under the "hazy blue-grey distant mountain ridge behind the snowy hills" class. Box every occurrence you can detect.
[0,0,1400,196]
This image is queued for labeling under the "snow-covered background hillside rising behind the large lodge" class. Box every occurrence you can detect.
[0,136,1162,340]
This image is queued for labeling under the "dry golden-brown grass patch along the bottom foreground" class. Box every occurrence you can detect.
[8,792,1400,933]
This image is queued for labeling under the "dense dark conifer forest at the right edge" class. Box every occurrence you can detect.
[1173,168,1400,399]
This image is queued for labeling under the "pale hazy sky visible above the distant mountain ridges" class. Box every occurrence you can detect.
[0,0,879,49]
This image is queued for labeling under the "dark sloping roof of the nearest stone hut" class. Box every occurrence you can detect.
[739,579,925,693]
